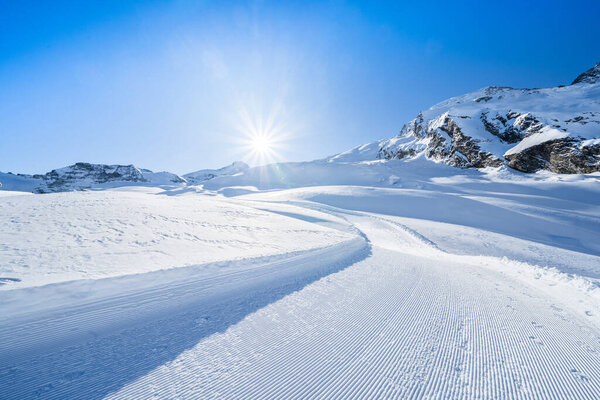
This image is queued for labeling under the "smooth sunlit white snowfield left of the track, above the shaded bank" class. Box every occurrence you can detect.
[0,188,349,290]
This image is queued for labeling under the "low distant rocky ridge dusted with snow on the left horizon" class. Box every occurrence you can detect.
[0,162,186,193]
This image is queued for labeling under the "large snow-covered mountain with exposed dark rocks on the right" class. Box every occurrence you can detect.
[330,63,600,173]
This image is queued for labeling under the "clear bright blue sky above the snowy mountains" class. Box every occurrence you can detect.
[0,0,600,173]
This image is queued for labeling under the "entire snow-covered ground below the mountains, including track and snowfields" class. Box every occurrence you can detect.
[0,163,600,399]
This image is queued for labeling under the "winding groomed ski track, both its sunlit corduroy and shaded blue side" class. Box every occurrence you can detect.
[0,193,600,399]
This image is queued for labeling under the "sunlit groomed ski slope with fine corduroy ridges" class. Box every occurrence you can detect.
[108,206,600,399]
